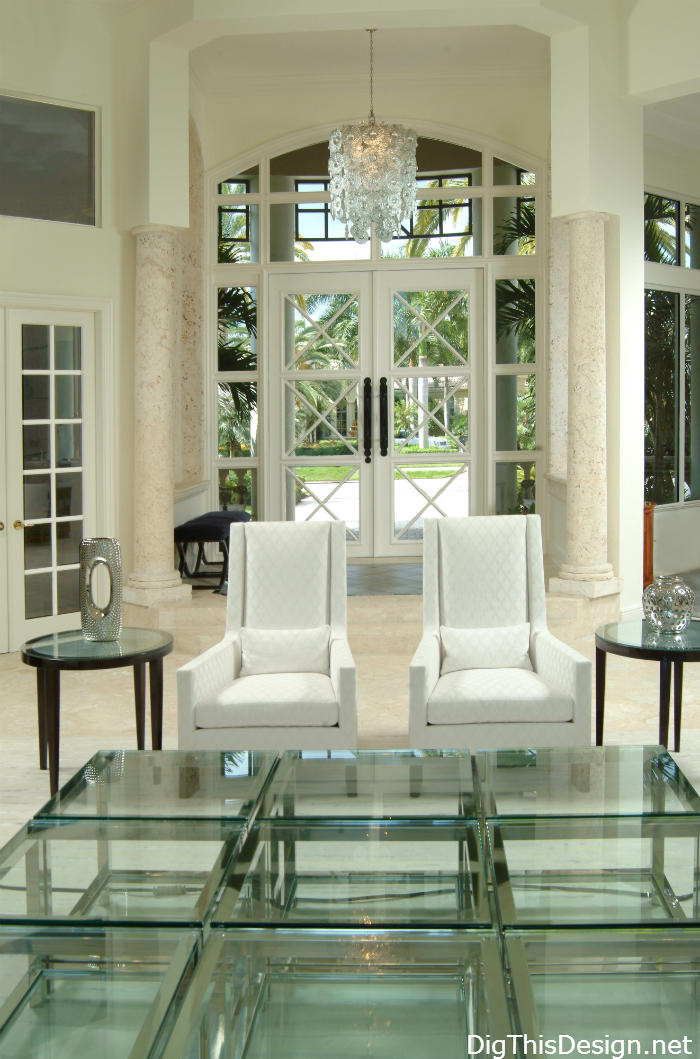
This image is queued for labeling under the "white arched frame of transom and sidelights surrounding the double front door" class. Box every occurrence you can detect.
[204,119,549,533]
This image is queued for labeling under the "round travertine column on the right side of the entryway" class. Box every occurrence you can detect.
[550,212,620,597]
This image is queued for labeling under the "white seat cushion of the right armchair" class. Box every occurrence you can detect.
[428,669,574,724]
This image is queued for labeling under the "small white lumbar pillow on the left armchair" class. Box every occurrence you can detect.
[240,625,330,677]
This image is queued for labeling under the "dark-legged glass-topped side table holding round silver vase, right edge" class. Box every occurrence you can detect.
[595,618,700,752]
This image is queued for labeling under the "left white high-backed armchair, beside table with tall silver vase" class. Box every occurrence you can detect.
[178,522,357,750]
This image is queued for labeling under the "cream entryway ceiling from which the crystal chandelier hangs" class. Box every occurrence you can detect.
[191,25,550,94]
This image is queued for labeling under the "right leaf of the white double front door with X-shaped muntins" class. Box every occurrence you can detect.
[375,269,479,555]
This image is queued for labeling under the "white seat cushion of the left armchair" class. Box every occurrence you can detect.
[195,672,338,728]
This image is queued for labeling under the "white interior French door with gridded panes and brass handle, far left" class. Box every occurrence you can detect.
[5,309,95,650]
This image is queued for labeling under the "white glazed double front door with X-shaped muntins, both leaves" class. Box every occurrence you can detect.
[266,268,482,558]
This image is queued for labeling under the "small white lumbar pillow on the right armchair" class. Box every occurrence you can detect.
[439,622,533,677]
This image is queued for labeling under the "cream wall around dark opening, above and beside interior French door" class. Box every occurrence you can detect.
[0,0,133,569]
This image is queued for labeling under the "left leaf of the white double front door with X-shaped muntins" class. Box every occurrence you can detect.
[270,273,373,556]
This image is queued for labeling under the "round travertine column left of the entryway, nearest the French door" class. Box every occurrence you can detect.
[124,225,192,607]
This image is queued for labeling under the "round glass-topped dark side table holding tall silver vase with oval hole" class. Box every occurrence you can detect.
[21,629,173,794]
